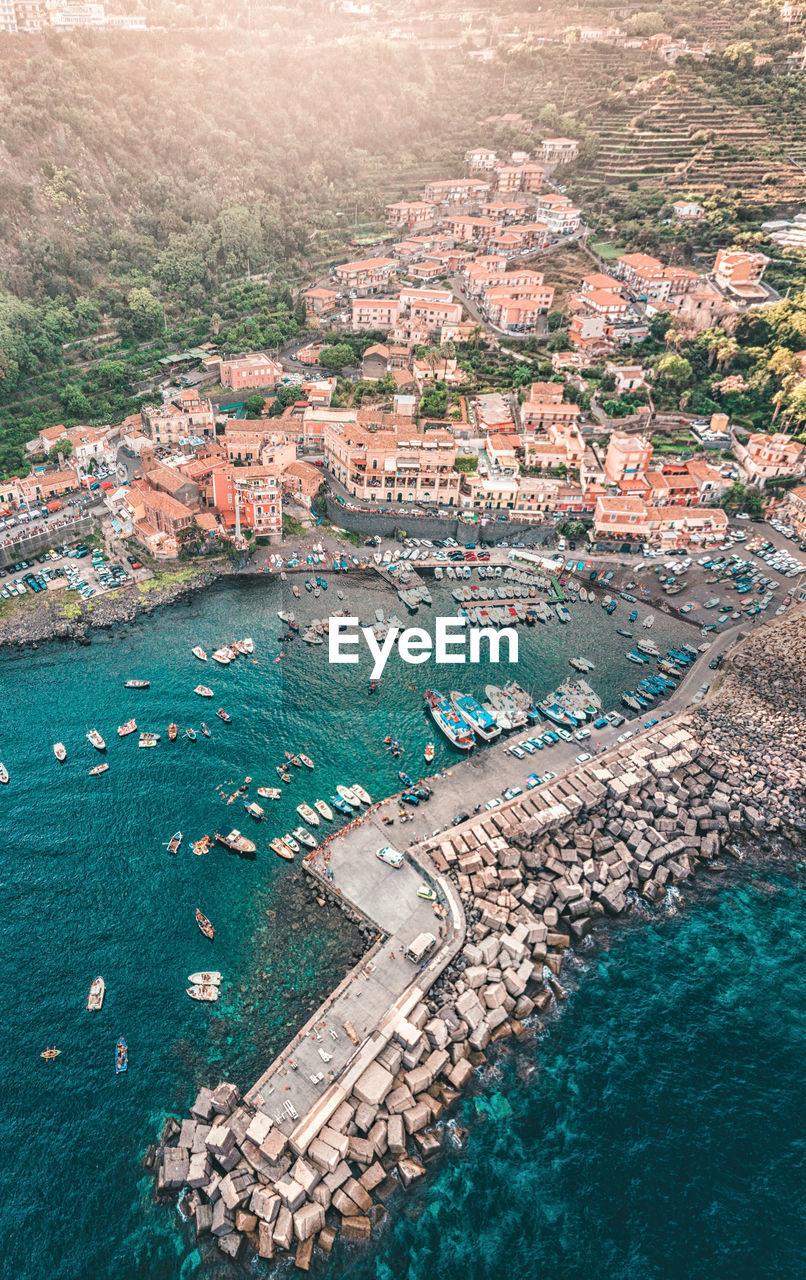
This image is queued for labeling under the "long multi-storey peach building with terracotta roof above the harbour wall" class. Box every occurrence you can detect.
[322,416,461,507]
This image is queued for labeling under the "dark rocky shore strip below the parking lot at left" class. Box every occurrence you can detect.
[0,566,229,646]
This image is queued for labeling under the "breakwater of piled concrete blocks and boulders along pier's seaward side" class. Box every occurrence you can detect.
[154,613,806,1270]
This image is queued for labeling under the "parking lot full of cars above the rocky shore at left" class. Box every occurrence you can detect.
[0,543,143,600]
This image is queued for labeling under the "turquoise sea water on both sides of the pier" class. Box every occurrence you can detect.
[0,582,803,1280]
